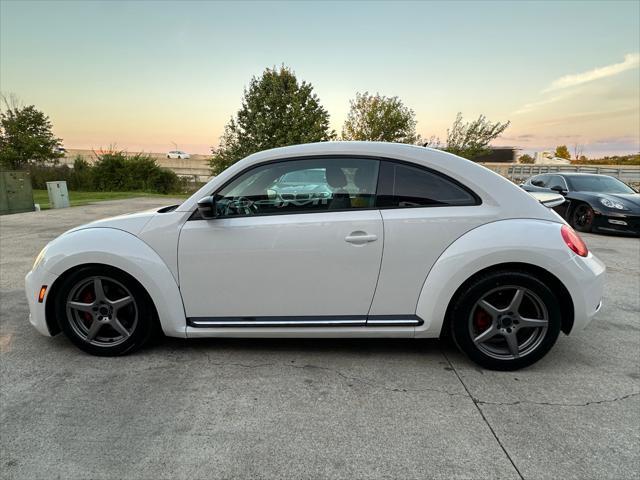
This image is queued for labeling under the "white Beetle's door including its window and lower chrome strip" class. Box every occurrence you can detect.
[178,157,383,326]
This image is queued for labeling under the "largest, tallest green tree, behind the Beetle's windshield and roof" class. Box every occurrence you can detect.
[209,65,335,175]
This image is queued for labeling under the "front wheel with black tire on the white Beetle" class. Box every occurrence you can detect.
[54,266,156,356]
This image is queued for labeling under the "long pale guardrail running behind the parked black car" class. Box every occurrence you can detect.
[482,163,640,183]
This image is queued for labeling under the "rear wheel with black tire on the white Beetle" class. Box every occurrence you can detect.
[450,271,561,370]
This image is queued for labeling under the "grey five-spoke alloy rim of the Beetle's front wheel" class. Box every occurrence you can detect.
[66,276,138,347]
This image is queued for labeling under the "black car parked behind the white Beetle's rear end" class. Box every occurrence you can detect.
[521,173,640,235]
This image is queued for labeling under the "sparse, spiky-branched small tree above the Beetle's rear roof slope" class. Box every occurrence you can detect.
[432,113,511,160]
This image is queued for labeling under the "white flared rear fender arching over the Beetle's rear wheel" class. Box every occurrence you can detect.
[415,219,591,337]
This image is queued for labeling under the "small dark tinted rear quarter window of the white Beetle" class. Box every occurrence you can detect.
[377,162,478,207]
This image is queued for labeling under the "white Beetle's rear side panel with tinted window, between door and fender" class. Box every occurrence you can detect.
[369,161,500,318]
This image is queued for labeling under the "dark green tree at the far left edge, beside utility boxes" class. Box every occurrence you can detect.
[0,96,63,170]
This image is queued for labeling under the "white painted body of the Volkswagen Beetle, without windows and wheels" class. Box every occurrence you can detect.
[26,142,605,354]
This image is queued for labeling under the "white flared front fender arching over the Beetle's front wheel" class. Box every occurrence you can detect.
[38,227,186,337]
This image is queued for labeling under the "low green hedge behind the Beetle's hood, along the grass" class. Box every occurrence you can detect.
[29,152,185,193]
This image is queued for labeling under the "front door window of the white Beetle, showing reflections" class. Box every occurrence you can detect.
[215,158,380,217]
